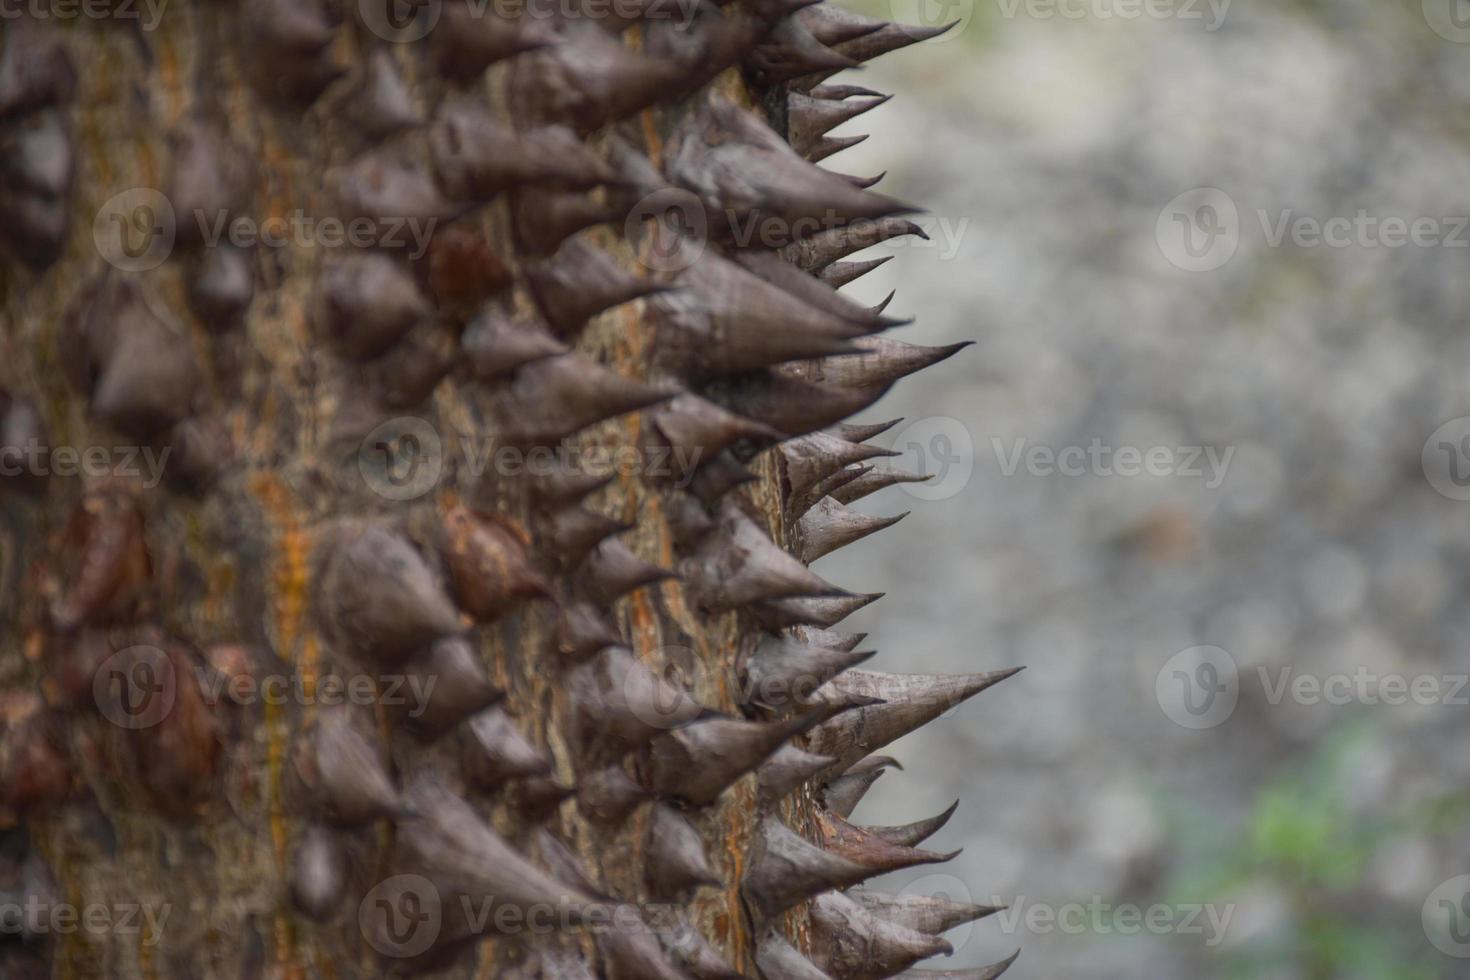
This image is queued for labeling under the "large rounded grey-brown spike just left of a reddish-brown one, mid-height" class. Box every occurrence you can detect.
[315,520,463,663]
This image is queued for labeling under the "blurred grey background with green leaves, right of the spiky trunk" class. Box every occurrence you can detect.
[817,0,1470,980]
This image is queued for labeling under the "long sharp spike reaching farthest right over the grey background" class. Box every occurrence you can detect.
[809,667,1022,765]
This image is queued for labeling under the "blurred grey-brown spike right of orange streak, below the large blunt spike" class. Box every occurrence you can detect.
[297,708,404,827]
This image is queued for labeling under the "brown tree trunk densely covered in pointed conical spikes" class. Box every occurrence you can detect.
[0,0,1005,980]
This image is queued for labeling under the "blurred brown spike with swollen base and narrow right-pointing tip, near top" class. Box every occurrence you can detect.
[429,98,617,201]
